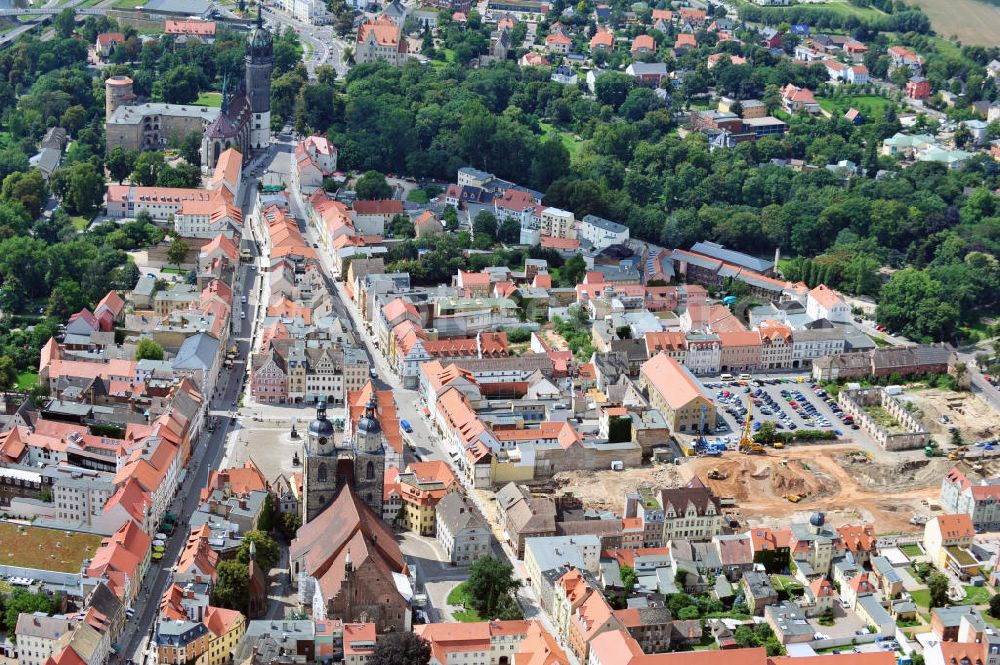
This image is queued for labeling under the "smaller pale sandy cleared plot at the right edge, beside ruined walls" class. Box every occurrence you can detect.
[902,388,1000,444]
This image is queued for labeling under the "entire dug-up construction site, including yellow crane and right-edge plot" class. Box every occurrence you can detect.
[508,386,1000,533]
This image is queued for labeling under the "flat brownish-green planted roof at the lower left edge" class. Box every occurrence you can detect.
[0,522,101,573]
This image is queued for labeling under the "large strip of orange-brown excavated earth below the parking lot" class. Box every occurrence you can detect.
[548,444,952,533]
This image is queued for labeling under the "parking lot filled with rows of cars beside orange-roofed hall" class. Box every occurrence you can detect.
[702,375,867,445]
